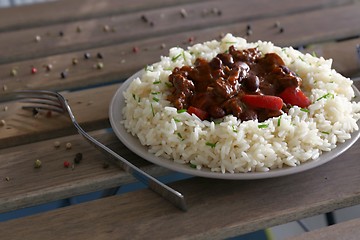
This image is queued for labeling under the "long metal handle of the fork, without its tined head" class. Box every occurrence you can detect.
[72,119,187,211]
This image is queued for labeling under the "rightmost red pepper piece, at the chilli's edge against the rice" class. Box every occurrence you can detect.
[279,87,311,108]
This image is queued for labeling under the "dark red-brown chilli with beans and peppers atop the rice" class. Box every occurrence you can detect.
[169,46,310,121]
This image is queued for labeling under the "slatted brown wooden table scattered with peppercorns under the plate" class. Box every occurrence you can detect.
[0,0,360,239]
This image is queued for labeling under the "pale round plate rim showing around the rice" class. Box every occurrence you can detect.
[109,71,360,180]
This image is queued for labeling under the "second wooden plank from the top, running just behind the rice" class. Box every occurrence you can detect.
[0,0,360,63]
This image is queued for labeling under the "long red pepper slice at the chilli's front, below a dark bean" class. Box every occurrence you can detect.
[241,95,283,111]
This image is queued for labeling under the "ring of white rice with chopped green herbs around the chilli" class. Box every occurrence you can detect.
[123,34,360,173]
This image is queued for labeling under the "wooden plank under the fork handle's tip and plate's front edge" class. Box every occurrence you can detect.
[0,142,360,239]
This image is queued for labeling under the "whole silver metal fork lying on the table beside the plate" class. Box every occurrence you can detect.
[16,90,187,211]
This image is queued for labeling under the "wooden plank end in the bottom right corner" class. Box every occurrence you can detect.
[288,218,360,240]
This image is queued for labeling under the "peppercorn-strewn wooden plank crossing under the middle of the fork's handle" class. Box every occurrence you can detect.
[0,130,169,213]
